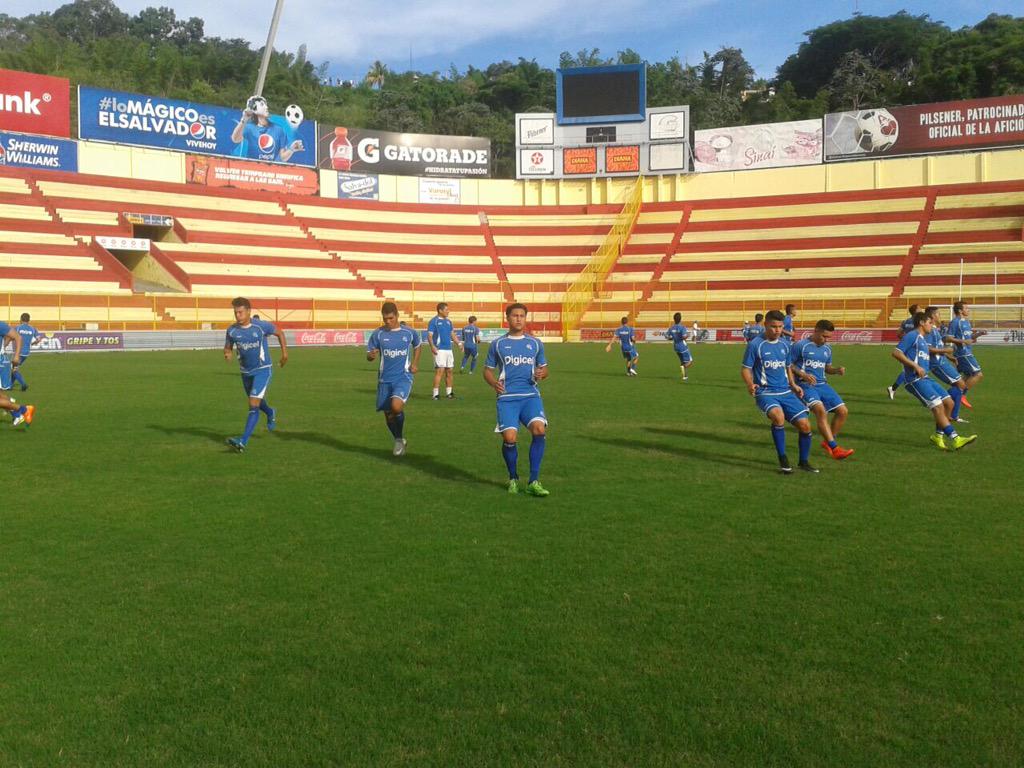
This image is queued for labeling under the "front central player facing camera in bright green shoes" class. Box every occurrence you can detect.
[483,303,550,497]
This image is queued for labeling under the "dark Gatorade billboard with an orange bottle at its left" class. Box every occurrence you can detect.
[317,126,490,178]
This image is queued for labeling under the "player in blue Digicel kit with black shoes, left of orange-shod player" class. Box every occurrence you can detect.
[739,309,818,474]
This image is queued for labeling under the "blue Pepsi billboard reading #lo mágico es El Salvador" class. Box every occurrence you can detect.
[78,85,316,167]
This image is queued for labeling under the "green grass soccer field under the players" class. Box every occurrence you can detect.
[6,345,1024,767]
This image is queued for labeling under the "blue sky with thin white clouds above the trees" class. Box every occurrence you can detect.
[3,0,1024,80]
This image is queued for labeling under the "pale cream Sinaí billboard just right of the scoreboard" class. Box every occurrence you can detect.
[693,120,821,172]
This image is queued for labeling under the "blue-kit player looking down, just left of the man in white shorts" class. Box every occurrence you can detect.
[367,301,421,456]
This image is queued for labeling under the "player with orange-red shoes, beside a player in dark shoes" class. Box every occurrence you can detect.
[790,319,853,460]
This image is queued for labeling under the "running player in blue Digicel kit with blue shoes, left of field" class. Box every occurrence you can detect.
[224,296,288,454]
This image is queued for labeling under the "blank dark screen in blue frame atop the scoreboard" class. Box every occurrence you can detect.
[555,63,647,125]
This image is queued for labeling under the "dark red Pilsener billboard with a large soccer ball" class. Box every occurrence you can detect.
[825,95,1024,162]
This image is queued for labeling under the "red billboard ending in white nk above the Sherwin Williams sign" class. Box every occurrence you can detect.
[0,70,71,136]
